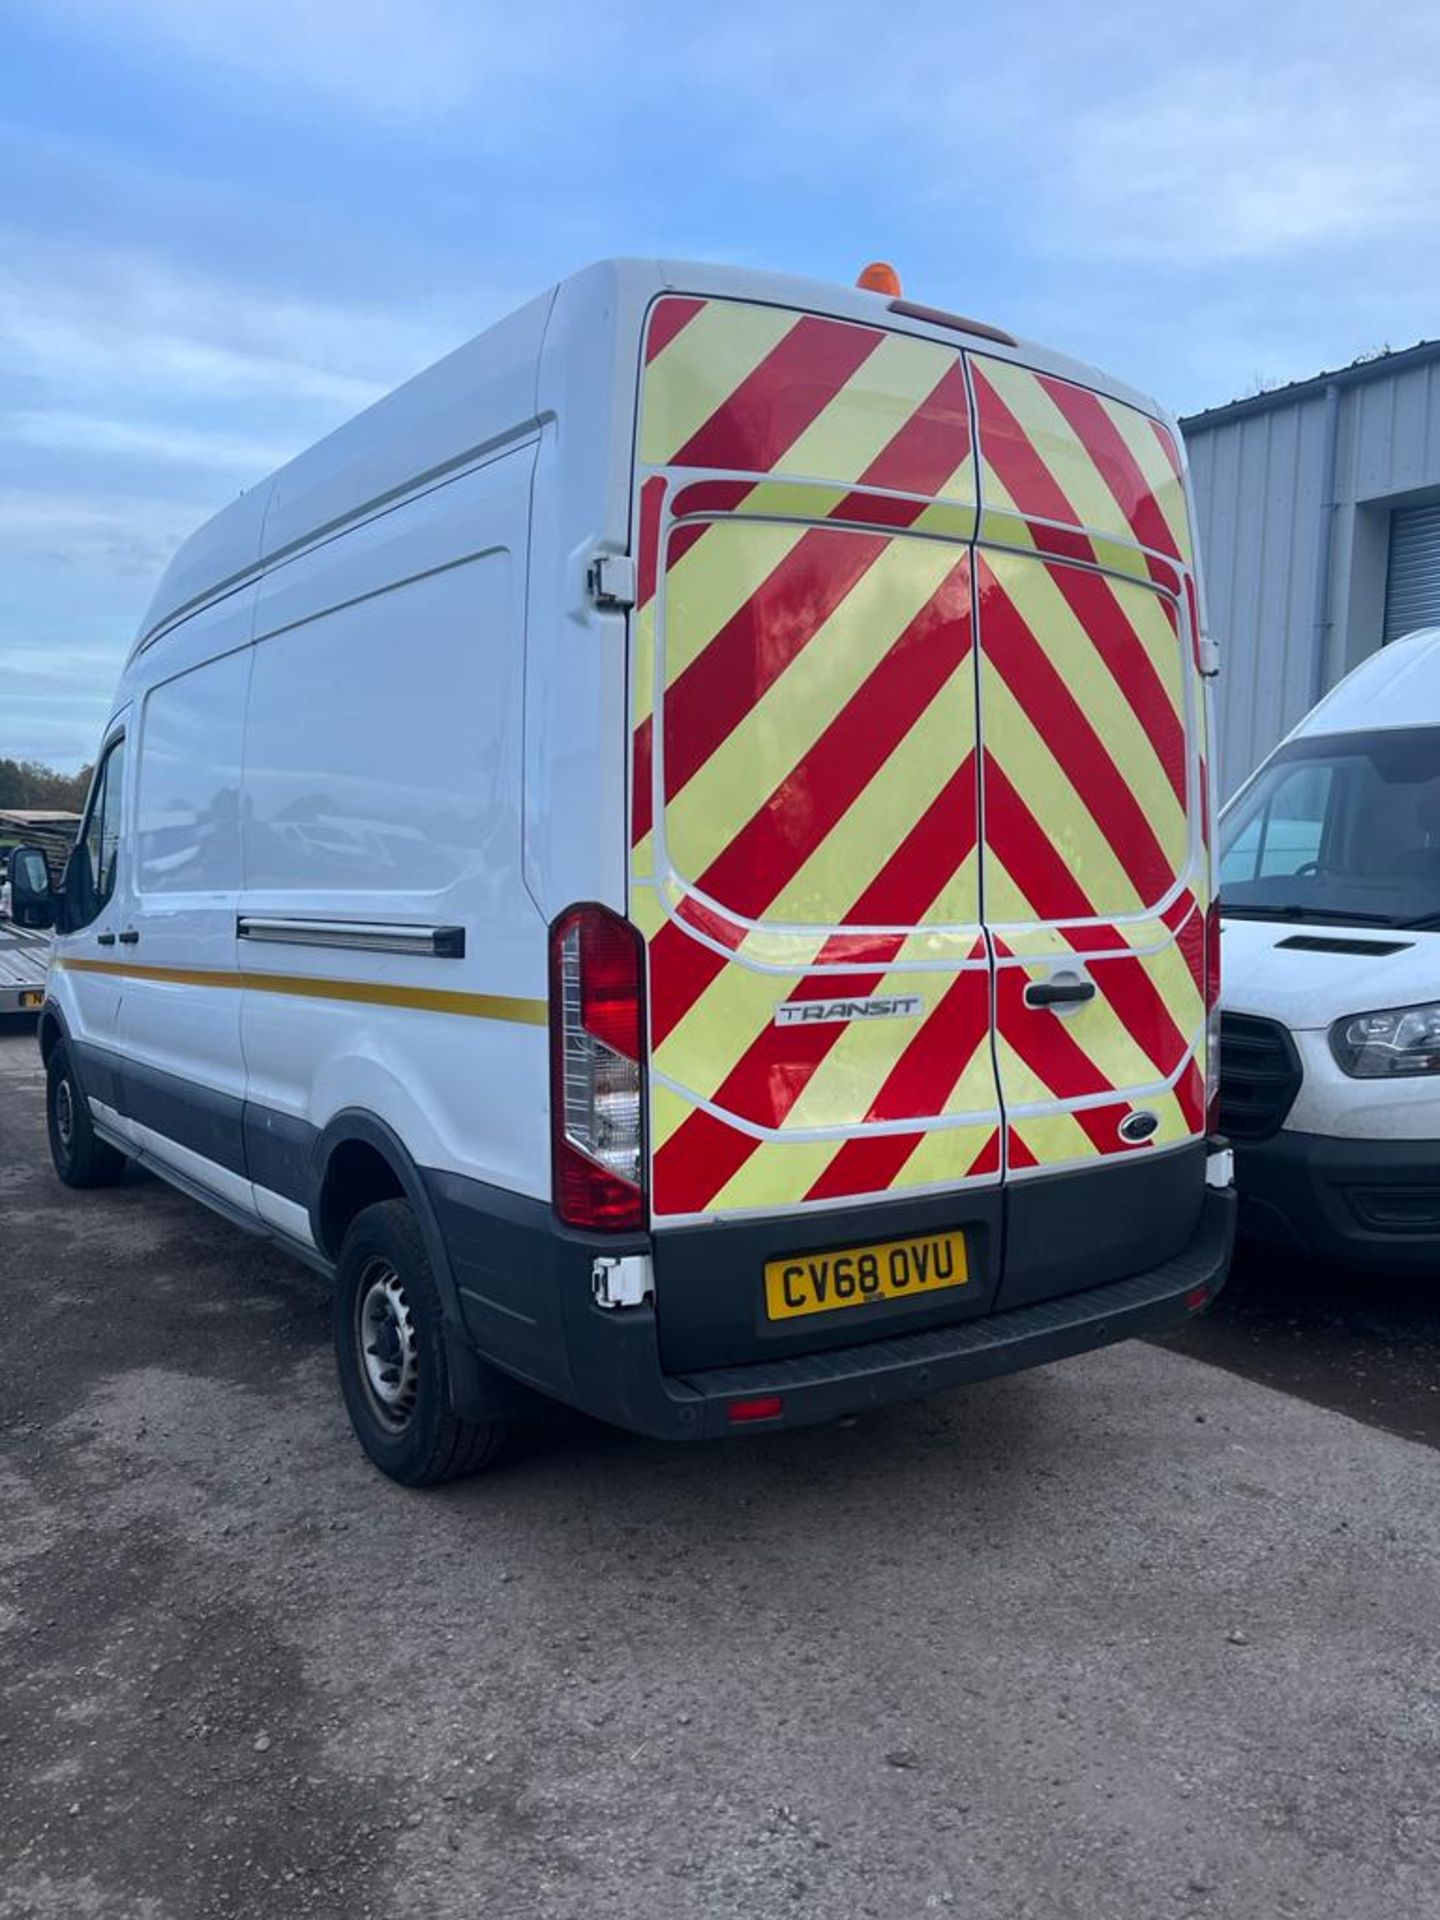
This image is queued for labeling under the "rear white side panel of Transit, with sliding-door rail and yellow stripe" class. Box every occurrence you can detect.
[240,445,549,1206]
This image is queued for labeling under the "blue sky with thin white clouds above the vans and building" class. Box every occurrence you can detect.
[0,0,1440,768]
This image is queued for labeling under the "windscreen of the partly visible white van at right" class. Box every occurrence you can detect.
[1219,728,1440,927]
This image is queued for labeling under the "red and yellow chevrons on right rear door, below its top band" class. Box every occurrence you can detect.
[977,537,1204,1169]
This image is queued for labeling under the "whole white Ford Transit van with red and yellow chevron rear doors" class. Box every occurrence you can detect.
[8,261,1233,1482]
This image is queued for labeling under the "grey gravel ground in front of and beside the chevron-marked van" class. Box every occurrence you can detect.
[0,1035,1440,1920]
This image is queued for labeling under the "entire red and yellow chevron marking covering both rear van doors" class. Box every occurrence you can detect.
[632,298,1204,1215]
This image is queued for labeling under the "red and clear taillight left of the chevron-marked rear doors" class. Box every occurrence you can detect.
[549,906,645,1233]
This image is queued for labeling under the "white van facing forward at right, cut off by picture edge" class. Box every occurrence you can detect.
[1221,628,1440,1273]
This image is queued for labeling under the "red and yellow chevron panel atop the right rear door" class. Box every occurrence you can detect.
[970,353,1190,593]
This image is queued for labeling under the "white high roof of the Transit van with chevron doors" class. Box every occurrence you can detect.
[131,259,1179,659]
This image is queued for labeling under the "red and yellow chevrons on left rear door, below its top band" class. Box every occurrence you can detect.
[636,518,998,1213]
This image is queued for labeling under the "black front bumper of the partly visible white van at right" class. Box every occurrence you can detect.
[1235,1129,1440,1273]
